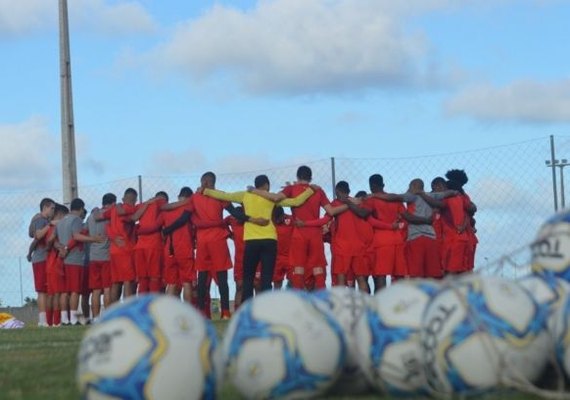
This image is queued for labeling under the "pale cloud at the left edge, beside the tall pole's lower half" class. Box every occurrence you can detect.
[0,118,59,190]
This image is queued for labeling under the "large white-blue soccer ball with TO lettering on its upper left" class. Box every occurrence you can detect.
[421,275,551,395]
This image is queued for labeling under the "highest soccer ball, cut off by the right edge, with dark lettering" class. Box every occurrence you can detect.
[531,210,570,281]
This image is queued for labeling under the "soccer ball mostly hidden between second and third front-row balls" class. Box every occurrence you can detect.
[314,286,369,395]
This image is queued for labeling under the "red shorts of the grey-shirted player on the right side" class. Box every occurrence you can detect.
[406,236,443,278]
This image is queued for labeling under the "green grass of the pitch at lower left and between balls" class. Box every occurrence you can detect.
[0,321,535,400]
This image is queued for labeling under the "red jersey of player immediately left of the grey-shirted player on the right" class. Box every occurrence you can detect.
[362,197,406,246]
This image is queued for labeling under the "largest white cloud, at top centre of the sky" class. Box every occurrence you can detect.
[150,0,458,94]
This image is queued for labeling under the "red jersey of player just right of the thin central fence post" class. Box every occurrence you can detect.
[332,199,365,257]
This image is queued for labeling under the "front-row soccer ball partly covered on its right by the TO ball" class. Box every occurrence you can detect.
[355,279,439,396]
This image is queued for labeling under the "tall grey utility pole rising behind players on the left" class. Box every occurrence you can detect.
[59,0,78,204]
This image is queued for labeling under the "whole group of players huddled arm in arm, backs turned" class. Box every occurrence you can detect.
[28,166,477,326]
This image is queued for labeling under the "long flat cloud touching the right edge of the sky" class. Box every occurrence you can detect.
[445,79,570,123]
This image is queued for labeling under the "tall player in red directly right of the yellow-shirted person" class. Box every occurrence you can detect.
[266,165,332,289]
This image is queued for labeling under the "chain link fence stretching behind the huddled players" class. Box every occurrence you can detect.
[0,136,570,306]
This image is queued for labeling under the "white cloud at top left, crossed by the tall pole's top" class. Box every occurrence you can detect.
[0,0,156,38]
